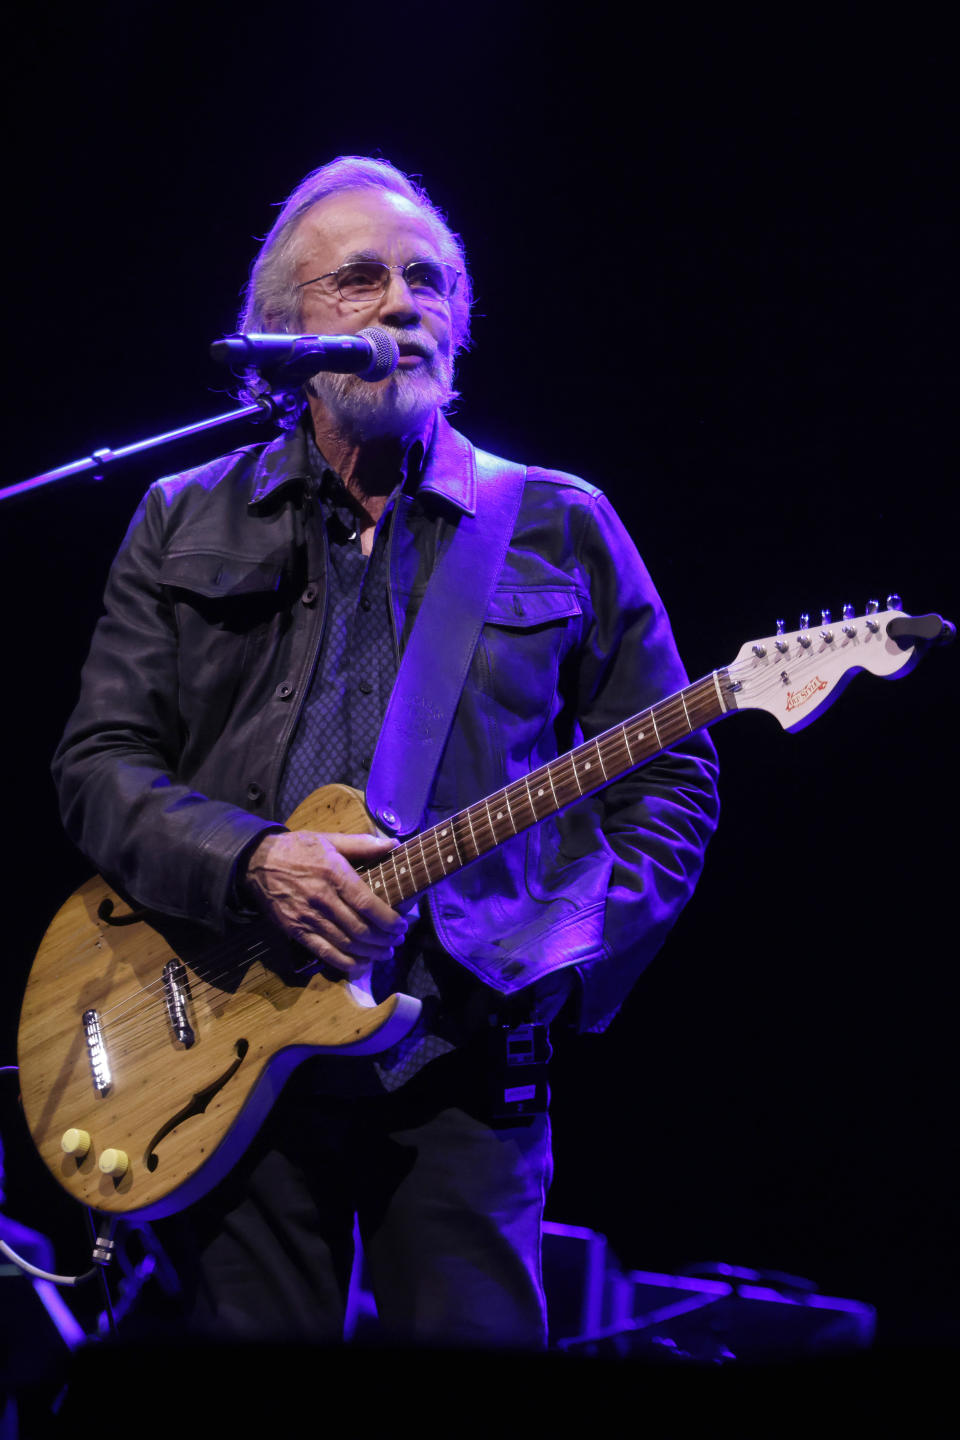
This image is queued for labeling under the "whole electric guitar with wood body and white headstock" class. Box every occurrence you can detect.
[19,598,953,1218]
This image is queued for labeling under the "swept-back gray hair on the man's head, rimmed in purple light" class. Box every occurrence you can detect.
[237,156,474,411]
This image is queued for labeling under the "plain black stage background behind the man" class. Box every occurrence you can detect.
[0,0,960,1345]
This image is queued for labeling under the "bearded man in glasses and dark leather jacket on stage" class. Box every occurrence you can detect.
[55,157,717,1346]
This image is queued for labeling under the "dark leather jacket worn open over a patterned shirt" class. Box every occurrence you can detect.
[53,418,718,1028]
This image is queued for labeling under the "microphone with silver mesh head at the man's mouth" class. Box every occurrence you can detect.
[210,325,400,390]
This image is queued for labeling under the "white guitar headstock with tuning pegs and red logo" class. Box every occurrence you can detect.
[724,595,953,730]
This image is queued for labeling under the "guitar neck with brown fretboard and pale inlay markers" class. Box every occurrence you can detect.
[361,670,735,906]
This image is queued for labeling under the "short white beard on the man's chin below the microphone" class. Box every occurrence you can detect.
[307,325,456,439]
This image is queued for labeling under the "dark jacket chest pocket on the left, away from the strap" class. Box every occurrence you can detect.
[160,550,288,708]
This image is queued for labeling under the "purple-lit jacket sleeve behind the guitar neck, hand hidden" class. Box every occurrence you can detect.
[564,495,720,1030]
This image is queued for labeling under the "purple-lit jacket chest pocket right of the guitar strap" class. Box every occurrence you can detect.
[481,589,581,720]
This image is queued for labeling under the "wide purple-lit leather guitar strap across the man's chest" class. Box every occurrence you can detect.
[367,449,527,835]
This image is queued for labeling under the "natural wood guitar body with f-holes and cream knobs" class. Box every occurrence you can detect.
[17,785,420,1218]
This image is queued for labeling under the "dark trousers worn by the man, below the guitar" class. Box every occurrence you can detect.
[155,1050,553,1348]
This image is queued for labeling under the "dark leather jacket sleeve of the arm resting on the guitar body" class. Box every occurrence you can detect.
[53,484,276,927]
